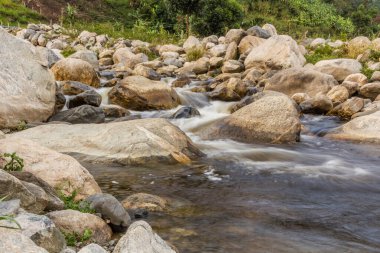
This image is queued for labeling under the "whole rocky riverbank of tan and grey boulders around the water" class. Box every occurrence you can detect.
[0,24,380,253]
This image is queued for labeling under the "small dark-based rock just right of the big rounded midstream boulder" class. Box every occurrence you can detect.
[299,94,334,114]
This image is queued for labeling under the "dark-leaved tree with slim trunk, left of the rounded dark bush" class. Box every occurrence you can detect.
[166,0,200,36]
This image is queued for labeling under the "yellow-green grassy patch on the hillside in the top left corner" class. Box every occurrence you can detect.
[0,0,44,25]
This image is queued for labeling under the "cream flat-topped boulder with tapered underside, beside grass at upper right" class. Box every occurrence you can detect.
[315,59,362,82]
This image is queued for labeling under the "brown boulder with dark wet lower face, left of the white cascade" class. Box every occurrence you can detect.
[108,76,180,111]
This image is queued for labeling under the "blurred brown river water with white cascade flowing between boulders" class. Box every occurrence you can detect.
[85,79,380,253]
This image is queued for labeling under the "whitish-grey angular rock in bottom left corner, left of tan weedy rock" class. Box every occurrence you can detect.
[0,213,66,253]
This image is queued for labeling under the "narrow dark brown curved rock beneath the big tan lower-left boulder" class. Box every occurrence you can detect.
[10,171,64,211]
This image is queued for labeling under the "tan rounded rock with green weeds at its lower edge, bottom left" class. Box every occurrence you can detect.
[47,210,112,243]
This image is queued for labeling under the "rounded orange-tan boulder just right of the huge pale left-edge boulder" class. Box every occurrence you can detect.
[51,58,100,88]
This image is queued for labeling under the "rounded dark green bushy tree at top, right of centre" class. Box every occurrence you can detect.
[193,0,243,35]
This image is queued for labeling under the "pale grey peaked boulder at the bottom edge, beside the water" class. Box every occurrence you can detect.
[113,221,176,253]
